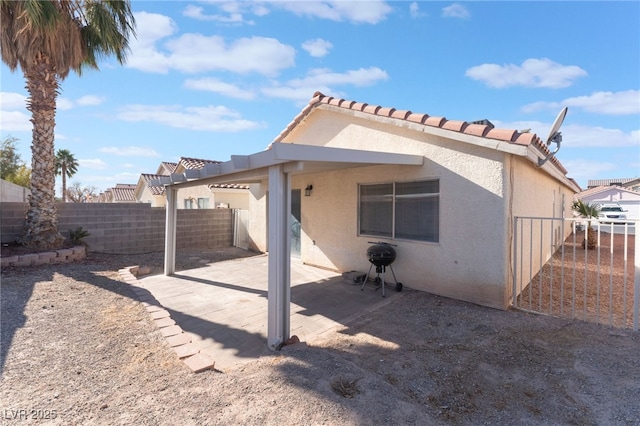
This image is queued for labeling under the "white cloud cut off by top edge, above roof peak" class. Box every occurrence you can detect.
[270,0,393,24]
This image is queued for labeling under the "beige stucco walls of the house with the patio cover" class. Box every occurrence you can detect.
[249,106,574,308]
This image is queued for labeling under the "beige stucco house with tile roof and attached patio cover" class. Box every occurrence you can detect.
[158,92,580,347]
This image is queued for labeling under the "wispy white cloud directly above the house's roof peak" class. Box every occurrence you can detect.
[262,67,389,102]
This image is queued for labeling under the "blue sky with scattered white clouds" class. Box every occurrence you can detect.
[0,0,640,191]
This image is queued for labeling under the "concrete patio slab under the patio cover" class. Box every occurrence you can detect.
[139,255,403,371]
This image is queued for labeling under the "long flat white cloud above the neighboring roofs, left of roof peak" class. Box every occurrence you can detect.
[118,105,261,132]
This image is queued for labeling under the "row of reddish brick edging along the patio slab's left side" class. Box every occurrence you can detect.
[118,266,215,373]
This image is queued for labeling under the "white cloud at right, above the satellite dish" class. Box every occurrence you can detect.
[465,58,587,89]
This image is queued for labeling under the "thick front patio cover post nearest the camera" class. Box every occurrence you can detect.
[267,165,291,350]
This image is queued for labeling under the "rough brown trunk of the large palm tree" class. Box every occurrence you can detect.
[21,54,64,248]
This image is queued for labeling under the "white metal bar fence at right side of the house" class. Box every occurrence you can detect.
[512,217,640,331]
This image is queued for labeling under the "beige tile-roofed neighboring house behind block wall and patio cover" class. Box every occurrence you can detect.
[134,157,249,210]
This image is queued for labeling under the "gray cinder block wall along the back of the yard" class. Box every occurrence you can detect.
[0,203,233,254]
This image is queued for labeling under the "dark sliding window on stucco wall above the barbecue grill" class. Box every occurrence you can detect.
[359,180,440,242]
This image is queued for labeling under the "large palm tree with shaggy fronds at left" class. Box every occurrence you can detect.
[0,0,135,248]
